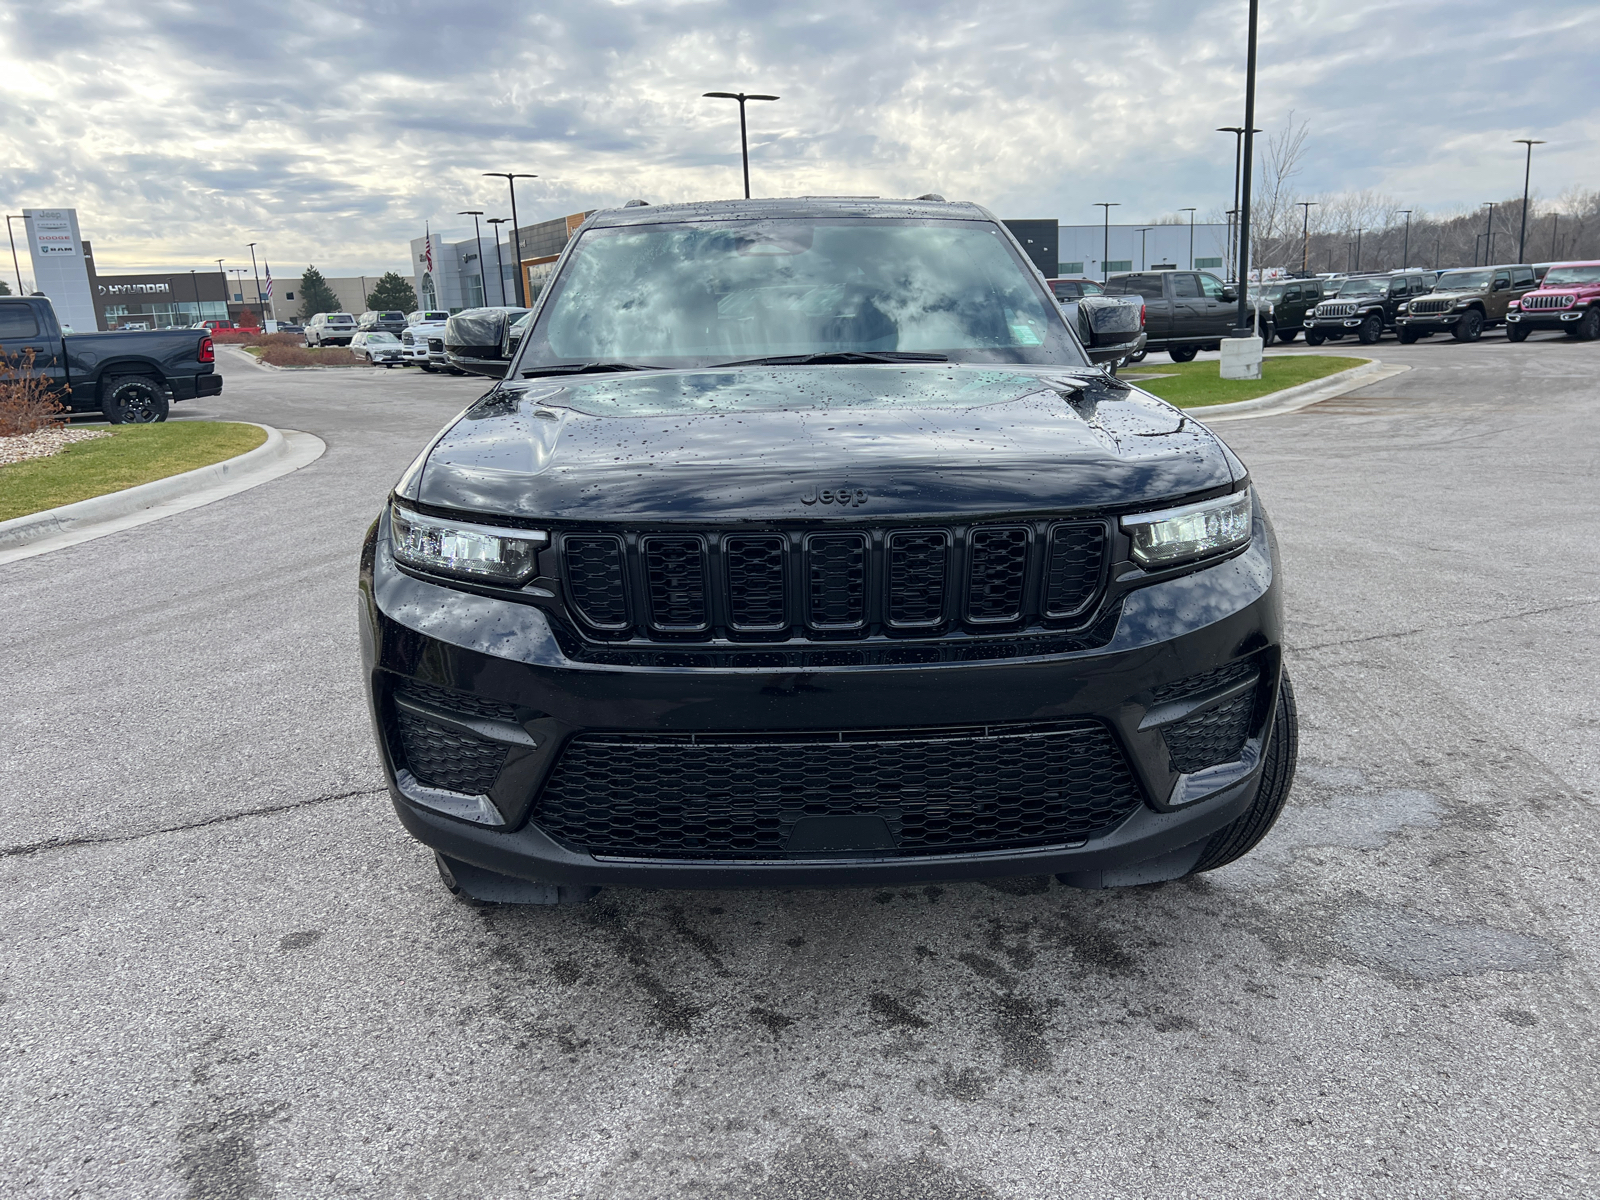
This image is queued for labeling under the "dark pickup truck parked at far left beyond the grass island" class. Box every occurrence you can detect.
[0,296,222,426]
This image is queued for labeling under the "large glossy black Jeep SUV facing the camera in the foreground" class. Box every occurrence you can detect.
[360,200,1296,902]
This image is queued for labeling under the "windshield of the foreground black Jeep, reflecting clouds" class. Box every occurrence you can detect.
[518,218,1086,370]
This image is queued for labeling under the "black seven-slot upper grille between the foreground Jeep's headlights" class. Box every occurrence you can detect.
[560,520,1107,642]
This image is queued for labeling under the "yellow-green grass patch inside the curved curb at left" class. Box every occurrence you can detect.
[0,421,267,520]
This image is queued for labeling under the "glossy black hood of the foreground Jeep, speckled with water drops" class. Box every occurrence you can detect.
[412,365,1243,520]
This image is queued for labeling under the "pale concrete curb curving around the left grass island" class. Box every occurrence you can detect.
[0,421,328,563]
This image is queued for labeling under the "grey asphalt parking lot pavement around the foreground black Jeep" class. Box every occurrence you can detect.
[0,334,1600,1200]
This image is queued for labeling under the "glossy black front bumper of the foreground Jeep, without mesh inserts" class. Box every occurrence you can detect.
[360,510,1282,888]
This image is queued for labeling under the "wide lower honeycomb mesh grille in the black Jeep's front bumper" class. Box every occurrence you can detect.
[534,722,1141,858]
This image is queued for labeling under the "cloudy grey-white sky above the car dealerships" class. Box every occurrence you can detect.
[0,0,1600,277]
